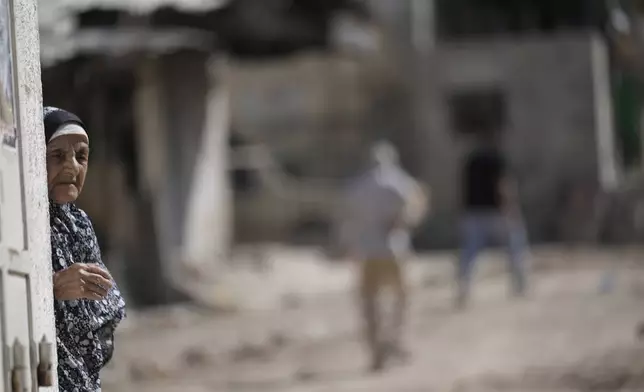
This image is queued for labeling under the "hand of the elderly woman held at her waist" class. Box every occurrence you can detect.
[54,263,114,301]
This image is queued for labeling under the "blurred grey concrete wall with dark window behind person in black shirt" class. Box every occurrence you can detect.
[415,34,612,246]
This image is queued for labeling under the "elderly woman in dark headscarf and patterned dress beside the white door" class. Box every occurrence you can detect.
[44,107,125,392]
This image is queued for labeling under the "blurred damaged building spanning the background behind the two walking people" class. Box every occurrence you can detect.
[221,0,638,249]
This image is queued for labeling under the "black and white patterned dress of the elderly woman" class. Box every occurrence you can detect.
[49,202,125,392]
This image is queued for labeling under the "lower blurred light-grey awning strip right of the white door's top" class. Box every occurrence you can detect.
[40,28,216,67]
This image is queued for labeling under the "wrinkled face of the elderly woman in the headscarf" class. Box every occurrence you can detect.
[47,135,89,204]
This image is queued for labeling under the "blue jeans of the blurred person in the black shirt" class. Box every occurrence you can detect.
[458,211,528,301]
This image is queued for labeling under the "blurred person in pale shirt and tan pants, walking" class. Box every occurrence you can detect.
[338,142,427,371]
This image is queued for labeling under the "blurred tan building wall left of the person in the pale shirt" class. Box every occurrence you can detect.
[230,54,375,242]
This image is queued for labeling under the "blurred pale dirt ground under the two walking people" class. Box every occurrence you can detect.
[103,249,644,392]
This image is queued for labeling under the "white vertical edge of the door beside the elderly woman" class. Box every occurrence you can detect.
[14,0,58,391]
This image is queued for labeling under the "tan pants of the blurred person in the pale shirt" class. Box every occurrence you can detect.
[360,259,407,369]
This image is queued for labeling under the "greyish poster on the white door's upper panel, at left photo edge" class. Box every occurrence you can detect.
[0,0,18,148]
